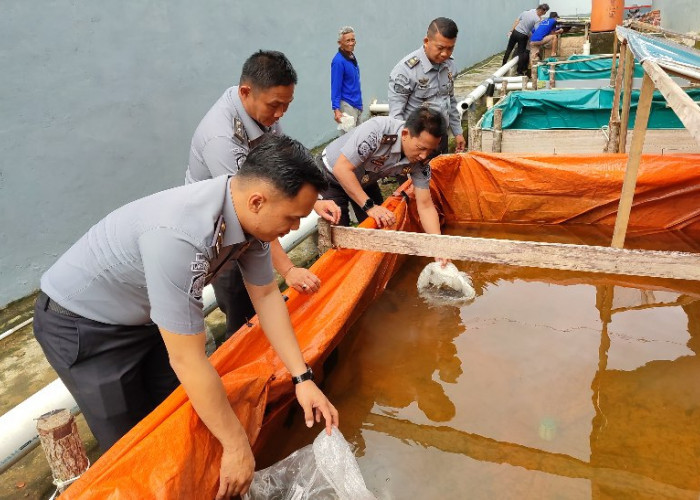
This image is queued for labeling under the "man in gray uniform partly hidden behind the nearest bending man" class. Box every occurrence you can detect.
[185,50,340,338]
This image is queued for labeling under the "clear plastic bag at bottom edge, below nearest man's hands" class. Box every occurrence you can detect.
[243,427,376,500]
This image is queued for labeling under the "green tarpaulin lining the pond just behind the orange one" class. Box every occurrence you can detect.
[482,89,700,130]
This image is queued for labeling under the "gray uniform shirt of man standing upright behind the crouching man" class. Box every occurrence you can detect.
[389,47,462,135]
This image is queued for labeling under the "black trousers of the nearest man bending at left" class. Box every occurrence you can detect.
[34,292,179,451]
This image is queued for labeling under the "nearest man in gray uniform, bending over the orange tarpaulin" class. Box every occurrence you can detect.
[34,136,338,498]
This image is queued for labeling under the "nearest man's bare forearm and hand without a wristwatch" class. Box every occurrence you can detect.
[160,329,255,500]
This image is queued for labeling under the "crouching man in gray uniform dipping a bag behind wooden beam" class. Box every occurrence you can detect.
[321,108,447,262]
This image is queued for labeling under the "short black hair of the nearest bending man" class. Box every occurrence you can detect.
[236,134,328,198]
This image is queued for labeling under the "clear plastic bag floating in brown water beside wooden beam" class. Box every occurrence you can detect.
[417,262,476,306]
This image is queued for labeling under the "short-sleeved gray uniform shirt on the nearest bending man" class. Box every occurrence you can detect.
[41,176,273,334]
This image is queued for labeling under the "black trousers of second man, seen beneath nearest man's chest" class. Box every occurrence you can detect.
[211,262,255,339]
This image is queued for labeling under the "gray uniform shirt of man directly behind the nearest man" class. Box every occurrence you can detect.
[185,86,282,184]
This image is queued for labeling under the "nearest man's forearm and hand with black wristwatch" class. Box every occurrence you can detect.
[245,282,339,435]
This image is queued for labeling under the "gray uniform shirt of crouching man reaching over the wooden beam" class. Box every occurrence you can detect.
[321,116,430,189]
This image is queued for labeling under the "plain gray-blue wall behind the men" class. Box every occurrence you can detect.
[0,0,536,307]
